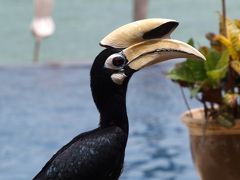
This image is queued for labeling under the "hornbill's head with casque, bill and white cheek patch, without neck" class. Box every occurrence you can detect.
[91,18,205,87]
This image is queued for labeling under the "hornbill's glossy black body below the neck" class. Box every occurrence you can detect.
[33,126,127,180]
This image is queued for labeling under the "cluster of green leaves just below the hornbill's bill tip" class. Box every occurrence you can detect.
[168,49,229,89]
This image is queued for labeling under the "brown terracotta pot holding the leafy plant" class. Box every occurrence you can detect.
[182,109,240,180]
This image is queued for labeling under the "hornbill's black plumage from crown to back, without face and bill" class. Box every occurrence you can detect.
[33,49,130,180]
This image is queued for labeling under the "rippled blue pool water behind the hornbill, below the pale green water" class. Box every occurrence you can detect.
[0,64,198,180]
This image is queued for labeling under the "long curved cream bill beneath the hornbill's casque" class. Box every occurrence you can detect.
[122,39,205,70]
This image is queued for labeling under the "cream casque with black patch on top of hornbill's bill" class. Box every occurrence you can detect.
[100,18,178,49]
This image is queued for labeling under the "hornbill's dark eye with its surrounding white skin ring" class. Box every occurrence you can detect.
[104,53,126,70]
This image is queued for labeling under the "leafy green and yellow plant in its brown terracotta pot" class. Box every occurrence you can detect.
[168,1,240,180]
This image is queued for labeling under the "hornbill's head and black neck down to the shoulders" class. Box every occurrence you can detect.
[91,19,205,129]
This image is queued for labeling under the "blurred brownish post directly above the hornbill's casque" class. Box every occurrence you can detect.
[133,0,148,21]
